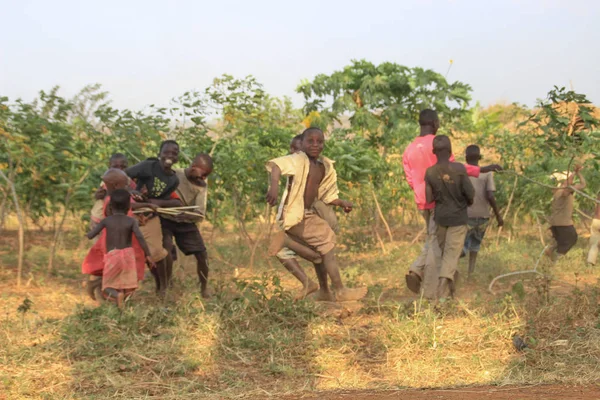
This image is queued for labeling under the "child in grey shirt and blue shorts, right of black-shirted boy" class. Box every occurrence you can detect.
[463,144,504,277]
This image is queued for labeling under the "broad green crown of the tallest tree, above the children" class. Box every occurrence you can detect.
[296,60,471,142]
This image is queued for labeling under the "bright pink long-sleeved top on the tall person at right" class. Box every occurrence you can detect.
[402,135,480,210]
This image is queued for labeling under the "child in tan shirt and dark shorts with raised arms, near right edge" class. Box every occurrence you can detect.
[546,165,586,262]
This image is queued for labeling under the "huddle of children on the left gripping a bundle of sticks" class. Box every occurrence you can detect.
[82,140,213,306]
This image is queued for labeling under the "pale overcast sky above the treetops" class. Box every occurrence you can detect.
[0,0,600,109]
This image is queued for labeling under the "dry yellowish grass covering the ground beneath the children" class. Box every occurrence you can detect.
[0,223,600,399]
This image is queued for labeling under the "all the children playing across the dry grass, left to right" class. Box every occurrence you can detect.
[83,110,600,305]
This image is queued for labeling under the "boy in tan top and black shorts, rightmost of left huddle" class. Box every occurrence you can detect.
[160,154,213,299]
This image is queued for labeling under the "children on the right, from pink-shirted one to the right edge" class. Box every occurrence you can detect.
[403,110,600,299]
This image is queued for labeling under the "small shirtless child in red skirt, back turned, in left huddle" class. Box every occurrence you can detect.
[87,189,152,308]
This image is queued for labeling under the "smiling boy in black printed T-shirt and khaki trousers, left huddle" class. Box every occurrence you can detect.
[125,140,181,296]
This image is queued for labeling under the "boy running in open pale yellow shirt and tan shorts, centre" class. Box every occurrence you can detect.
[267,128,367,301]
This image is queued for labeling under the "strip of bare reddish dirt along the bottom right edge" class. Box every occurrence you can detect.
[282,385,600,400]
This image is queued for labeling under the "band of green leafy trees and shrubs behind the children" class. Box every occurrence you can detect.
[0,60,600,258]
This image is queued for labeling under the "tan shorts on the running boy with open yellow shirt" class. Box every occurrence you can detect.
[287,210,335,256]
